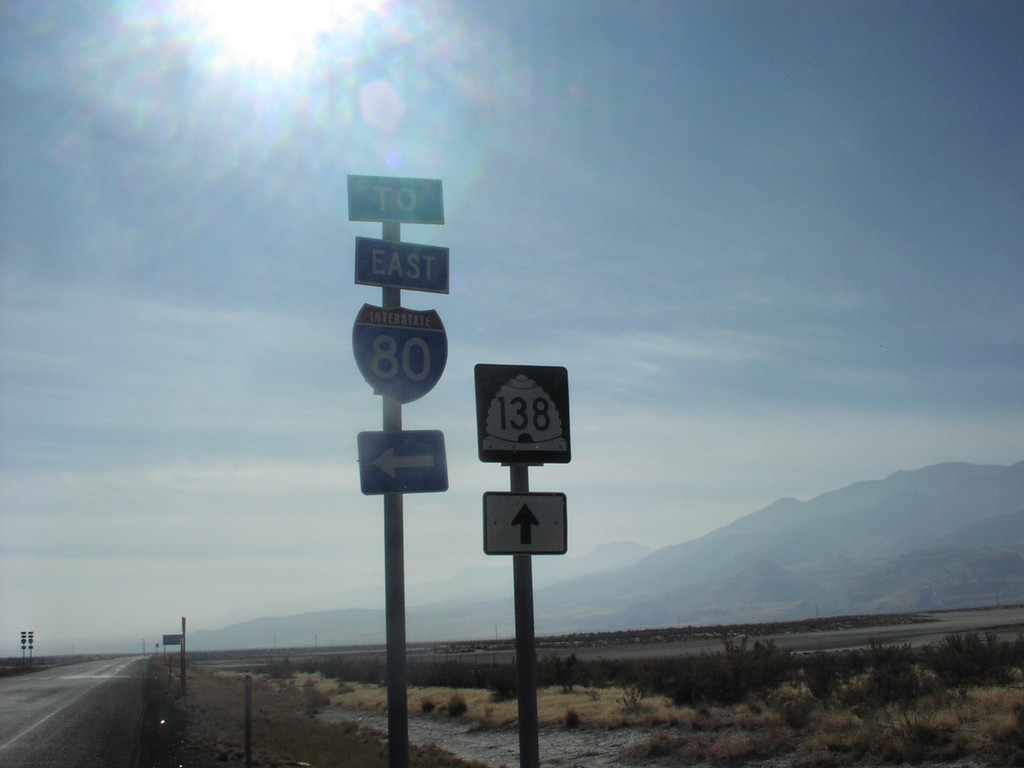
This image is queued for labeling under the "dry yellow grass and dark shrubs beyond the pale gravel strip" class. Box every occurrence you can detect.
[329,683,1024,767]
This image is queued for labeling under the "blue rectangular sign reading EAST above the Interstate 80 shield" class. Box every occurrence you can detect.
[355,238,449,293]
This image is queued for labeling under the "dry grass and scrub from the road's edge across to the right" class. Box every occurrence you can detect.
[175,669,1024,768]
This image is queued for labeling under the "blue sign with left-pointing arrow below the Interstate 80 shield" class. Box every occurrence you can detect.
[356,429,447,496]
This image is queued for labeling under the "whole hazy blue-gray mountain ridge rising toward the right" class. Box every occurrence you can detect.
[186,462,1024,649]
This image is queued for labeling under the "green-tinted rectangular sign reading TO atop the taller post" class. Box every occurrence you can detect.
[348,176,444,224]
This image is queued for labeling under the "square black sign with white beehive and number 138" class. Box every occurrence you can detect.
[474,364,571,464]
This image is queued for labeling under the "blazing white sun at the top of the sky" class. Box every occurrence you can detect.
[185,0,385,76]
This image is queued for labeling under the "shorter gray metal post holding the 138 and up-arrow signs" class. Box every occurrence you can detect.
[509,464,541,768]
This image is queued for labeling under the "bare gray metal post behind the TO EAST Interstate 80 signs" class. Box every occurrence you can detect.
[381,221,409,768]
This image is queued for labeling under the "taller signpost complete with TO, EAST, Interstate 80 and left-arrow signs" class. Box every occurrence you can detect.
[348,176,449,768]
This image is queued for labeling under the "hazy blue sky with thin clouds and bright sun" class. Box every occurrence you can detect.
[0,0,1024,655]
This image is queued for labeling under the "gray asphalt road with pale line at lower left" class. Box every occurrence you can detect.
[0,658,146,768]
